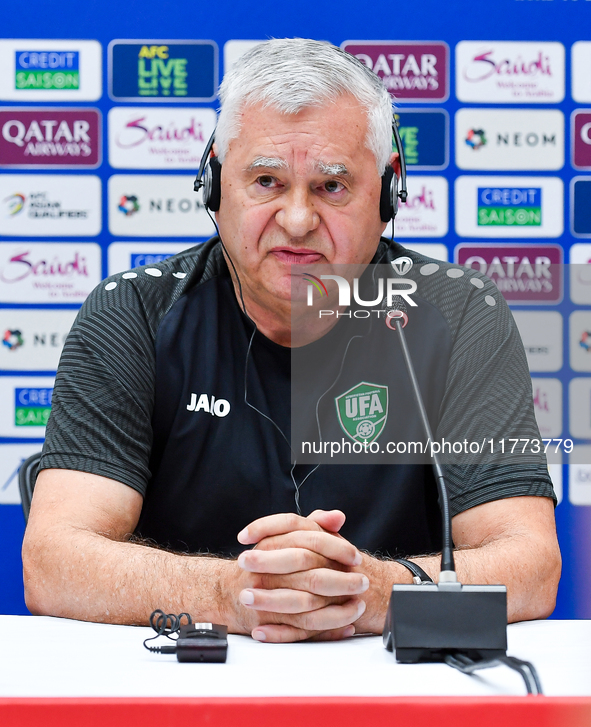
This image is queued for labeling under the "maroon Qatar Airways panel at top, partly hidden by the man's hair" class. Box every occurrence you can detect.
[341,40,449,103]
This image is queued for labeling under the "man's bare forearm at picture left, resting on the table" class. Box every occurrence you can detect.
[23,529,241,631]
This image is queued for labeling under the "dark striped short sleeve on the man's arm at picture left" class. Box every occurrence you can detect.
[40,281,155,495]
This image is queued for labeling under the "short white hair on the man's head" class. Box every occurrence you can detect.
[215,38,392,175]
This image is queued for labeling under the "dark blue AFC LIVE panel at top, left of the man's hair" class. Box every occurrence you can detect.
[109,40,218,103]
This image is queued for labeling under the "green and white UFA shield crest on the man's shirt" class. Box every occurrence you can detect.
[335,381,388,443]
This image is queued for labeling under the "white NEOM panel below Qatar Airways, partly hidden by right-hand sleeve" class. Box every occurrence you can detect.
[513,310,562,370]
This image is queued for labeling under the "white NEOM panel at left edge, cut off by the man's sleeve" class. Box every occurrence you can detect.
[0,308,78,371]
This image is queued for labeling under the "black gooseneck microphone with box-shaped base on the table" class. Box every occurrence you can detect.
[383,298,507,668]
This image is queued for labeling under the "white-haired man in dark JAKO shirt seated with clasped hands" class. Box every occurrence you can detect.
[23,39,560,642]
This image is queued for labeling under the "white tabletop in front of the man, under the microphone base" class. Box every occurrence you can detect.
[0,616,591,697]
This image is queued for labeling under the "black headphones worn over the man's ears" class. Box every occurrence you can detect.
[193,118,408,222]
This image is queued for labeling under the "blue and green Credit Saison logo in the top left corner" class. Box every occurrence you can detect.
[14,50,80,91]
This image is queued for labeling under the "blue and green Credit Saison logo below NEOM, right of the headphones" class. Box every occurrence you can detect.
[478,187,542,227]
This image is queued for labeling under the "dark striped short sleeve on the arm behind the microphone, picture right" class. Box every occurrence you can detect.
[436,278,556,515]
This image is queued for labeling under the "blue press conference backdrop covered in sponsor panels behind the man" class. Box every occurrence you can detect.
[0,0,591,618]
